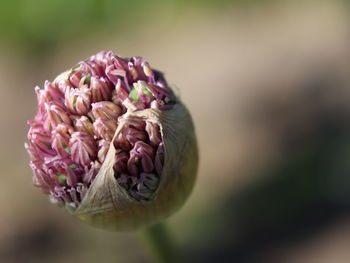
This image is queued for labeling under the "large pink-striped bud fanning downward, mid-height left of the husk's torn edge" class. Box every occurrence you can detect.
[69,132,97,166]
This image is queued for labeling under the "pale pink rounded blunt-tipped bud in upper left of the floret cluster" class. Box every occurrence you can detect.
[65,86,91,115]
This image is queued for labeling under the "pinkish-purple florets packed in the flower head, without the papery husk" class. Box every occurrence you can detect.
[25,52,175,207]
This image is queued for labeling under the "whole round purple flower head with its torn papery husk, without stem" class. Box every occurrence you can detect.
[25,51,198,229]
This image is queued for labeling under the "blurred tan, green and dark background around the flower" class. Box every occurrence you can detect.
[0,0,350,263]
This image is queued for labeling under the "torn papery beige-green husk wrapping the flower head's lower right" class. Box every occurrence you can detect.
[67,102,198,230]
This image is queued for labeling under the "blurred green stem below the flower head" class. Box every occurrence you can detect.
[142,223,178,263]
